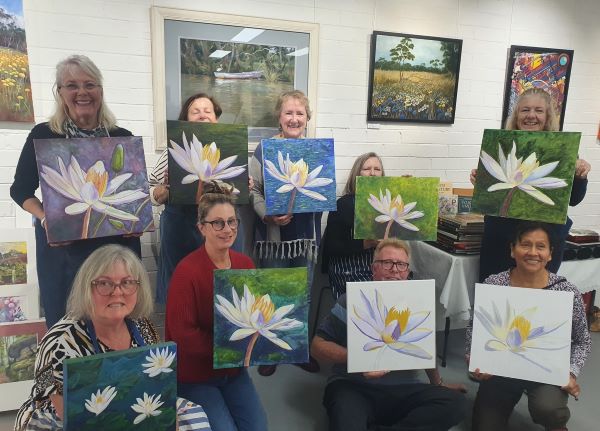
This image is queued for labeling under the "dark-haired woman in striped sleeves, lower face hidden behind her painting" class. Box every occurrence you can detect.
[148,93,243,304]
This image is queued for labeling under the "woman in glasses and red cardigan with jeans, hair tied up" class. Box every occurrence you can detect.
[165,184,267,431]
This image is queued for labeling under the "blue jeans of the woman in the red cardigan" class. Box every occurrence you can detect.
[178,369,267,431]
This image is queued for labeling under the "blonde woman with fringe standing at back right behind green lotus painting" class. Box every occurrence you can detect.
[471,88,591,282]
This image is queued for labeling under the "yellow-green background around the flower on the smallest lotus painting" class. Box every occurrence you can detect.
[354,177,439,240]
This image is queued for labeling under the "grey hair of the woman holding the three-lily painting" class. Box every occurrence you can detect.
[67,244,154,320]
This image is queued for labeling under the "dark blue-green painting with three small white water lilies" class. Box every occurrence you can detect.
[63,342,177,431]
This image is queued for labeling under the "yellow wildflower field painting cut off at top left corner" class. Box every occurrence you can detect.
[0,0,34,123]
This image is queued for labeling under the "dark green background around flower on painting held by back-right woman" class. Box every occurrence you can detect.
[473,129,581,224]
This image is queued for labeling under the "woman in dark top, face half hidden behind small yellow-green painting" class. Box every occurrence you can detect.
[322,152,384,299]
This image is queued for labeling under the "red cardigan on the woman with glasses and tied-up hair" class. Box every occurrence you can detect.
[165,246,254,383]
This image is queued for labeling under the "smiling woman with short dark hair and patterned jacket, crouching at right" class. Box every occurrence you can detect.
[465,222,592,431]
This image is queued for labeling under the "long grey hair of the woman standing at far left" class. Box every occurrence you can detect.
[48,54,117,135]
